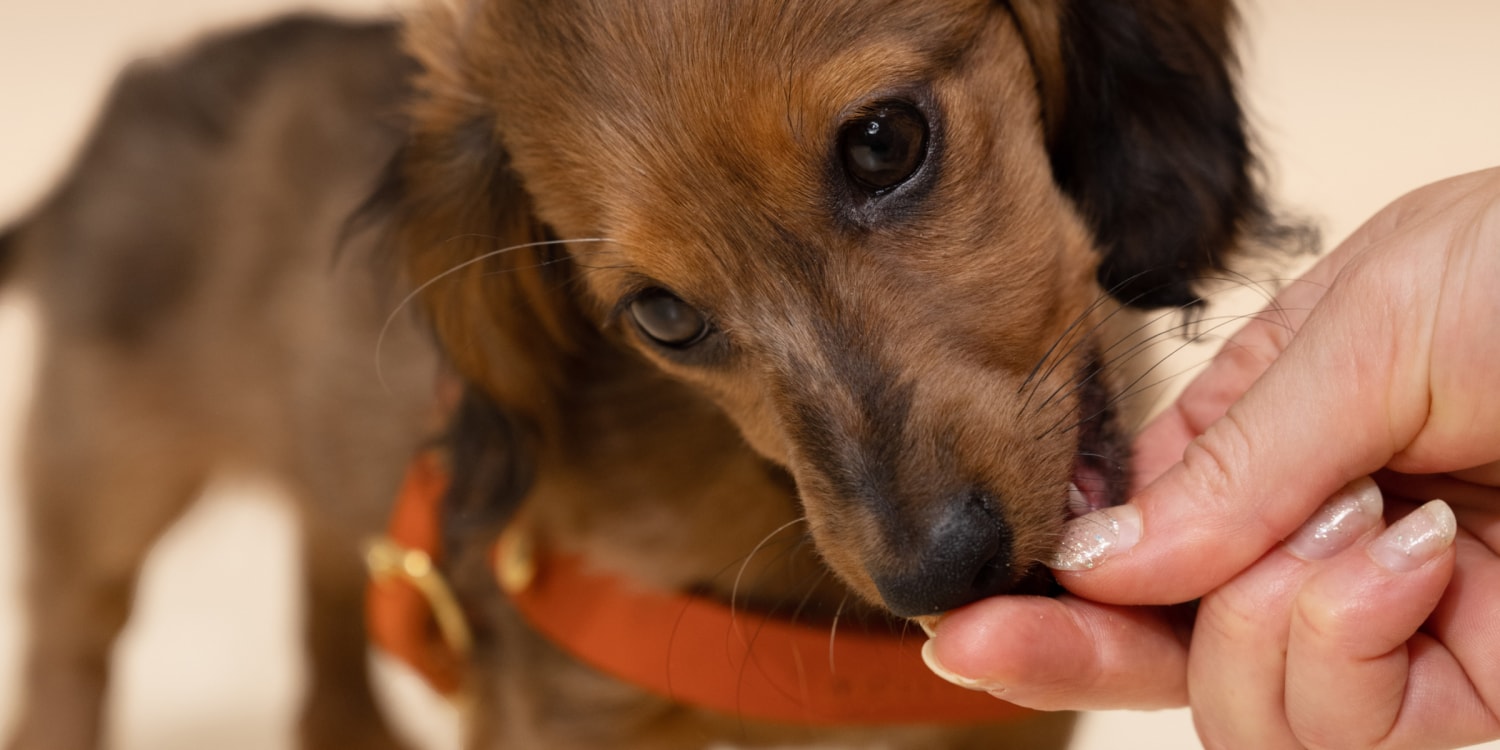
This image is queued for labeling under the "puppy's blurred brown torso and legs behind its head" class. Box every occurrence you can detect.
[3,20,440,749]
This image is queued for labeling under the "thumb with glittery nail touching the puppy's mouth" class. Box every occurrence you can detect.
[1053,192,1436,605]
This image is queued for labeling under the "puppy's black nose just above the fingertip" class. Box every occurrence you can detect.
[870,492,1014,617]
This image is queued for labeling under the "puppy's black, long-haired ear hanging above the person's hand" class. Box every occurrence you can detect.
[1010,0,1265,308]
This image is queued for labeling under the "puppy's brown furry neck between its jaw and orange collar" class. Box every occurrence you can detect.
[525,357,864,621]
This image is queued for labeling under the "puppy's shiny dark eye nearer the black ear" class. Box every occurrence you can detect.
[839,102,927,194]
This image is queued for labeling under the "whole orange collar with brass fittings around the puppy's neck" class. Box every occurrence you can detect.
[368,456,1032,726]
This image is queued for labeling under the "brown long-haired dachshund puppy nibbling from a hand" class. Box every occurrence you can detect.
[0,0,1266,749]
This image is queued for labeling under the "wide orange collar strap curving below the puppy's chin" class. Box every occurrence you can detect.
[497,533,1032,726]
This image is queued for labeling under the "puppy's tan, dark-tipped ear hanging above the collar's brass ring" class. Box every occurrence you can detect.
[366,119,591,555]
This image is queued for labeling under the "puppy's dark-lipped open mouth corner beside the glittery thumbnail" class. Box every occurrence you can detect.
[1067,363,1130,518]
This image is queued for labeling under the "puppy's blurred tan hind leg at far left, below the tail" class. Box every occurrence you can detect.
[11,373,206,750]
